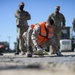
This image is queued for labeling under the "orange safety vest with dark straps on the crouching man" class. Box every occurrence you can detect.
[31,22,54,44]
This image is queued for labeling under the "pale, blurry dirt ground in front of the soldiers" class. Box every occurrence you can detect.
[0,52,75,75]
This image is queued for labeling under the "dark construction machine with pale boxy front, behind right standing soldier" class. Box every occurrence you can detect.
[60,27,75,51]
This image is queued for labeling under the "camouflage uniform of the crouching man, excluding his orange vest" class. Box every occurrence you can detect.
[23,24,62,54]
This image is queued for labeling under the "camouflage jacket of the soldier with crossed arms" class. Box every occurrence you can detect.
[15,9,31,27]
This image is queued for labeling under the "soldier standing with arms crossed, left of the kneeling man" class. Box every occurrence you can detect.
[15,2,31,55]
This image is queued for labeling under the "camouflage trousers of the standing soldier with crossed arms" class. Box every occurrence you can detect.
[16,28,27,53]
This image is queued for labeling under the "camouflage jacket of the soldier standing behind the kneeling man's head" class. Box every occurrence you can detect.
[49,12,66,32]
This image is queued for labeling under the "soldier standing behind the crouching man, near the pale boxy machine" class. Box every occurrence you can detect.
[49,6,65,54]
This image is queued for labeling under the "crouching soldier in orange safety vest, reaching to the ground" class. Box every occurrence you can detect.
[23,18,62,57]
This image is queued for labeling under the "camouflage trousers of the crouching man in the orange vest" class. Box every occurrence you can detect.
[23,32,58,53]
